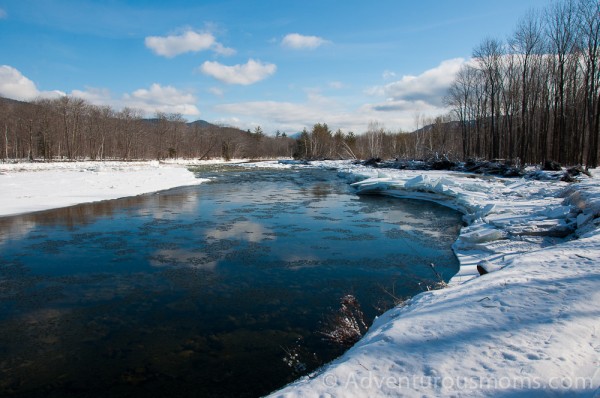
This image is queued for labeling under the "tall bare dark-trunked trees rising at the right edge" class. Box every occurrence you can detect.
[446,0,600,167]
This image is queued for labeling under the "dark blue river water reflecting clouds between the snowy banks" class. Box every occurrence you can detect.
[0,168,460,397]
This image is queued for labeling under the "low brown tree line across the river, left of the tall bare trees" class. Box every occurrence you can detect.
[0,96,460,161]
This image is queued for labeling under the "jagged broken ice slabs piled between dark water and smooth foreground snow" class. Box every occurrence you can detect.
[353,171,580,283]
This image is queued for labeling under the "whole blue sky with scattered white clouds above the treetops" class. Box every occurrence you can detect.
[0,0,548,134]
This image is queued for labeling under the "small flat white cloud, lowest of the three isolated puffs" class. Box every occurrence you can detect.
[200,59,277,86]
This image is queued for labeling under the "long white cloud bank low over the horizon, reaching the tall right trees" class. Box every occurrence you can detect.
[209,58,470,134]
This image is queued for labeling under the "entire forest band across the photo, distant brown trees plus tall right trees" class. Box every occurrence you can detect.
[0,0,600,168]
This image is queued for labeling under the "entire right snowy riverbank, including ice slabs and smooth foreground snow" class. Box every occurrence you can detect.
[272,162,600,397]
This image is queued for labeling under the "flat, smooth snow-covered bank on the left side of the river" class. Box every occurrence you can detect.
[0,161,205,216]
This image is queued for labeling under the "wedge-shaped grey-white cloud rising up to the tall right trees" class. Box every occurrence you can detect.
[367,58,467,107]
